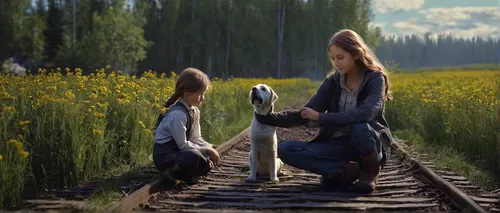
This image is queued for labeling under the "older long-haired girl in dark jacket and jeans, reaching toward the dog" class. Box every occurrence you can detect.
[255,29,392,192]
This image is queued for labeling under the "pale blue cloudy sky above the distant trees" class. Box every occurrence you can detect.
[372,0,500,38]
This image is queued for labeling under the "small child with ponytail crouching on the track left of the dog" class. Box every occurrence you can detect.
[153,68,220,185]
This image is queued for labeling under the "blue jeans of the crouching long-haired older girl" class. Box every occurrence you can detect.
[278,123,382,176]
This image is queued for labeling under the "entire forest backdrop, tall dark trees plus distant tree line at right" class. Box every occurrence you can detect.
[0,0,500,78]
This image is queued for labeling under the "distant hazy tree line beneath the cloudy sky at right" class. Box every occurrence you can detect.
[376,33,500,68]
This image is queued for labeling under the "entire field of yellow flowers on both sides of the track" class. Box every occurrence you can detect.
[0,68,500,208]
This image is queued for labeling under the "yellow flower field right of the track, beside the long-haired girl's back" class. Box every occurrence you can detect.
[386,71,500,174]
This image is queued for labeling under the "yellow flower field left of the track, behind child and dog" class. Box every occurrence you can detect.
[0,69,317,208]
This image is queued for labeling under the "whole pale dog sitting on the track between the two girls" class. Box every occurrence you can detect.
[245,84,283,182]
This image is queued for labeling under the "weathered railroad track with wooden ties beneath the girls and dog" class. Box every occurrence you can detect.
[103,127,500,212]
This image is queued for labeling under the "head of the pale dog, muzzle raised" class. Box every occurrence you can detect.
[250,84,278,115]
